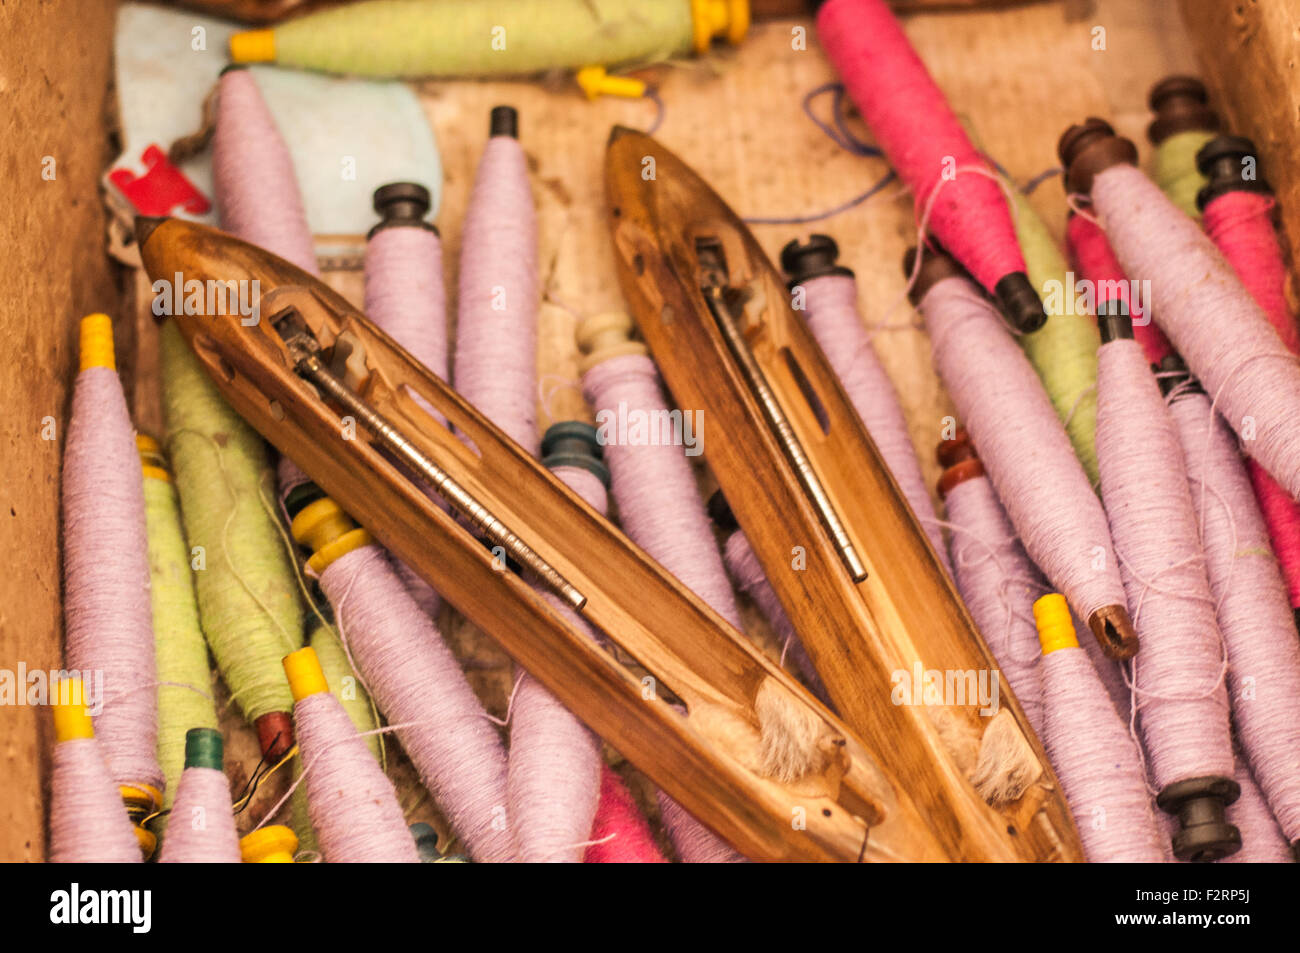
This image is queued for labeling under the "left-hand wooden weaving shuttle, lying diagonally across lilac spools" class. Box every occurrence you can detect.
[137,218,977,861]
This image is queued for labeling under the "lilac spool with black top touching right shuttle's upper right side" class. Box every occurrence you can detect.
[781,235,953,576]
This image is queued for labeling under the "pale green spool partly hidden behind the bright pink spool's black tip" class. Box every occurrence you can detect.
[1011,189,1101,486]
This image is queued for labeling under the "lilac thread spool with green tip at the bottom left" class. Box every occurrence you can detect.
[159,728,241,863]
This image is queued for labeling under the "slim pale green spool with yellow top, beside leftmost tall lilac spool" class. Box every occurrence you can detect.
[137,434,218,833]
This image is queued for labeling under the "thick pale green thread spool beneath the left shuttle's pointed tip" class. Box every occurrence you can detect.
[161,321,303,728]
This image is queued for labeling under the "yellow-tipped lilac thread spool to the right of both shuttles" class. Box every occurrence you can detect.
[1034,593,1165,863]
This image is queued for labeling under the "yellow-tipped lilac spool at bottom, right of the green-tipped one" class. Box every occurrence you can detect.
[285,647,420,863]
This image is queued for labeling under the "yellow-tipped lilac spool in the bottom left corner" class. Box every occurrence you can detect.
[49,677,143,863]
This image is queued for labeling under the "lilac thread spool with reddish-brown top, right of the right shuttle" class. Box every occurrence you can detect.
[937,432,1048,735]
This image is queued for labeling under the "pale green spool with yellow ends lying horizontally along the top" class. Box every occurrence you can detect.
[230,0,749,79]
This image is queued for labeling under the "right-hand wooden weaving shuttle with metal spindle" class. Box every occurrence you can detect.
[606,127,1082,861]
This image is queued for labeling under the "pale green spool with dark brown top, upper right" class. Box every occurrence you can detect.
[1147,75,1219,218]
